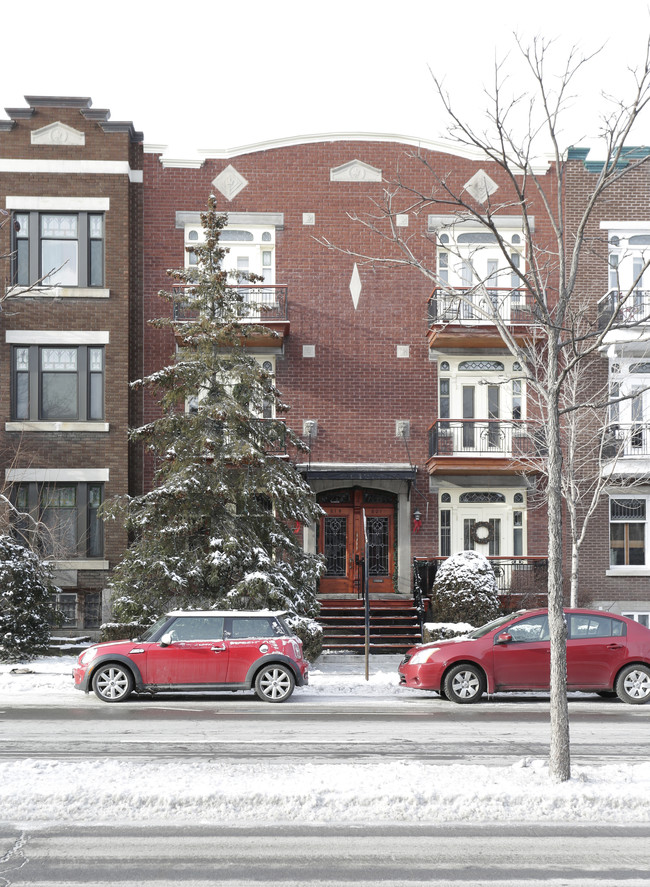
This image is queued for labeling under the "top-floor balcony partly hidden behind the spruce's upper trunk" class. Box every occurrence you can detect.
[173,284,290,348]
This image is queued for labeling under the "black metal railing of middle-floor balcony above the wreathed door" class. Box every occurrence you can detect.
[429,419,546,459]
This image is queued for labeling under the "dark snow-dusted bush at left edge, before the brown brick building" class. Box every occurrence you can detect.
[0,534,58,662]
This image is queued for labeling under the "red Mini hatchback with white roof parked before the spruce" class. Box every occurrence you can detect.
[72,610,309,702]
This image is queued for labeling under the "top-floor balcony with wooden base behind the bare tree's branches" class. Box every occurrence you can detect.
[428,286,534,348]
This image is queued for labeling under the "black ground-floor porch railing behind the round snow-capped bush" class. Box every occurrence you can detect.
[413,556,548,619]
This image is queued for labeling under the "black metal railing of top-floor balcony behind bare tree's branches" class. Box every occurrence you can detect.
[429,286,533,326]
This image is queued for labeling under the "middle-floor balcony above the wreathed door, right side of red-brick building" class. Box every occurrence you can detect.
[426,419,546,474]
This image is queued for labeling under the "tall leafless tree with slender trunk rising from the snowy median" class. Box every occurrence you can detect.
[321,39,650,781]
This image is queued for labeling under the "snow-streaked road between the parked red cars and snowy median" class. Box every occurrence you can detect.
[0,694,650,764]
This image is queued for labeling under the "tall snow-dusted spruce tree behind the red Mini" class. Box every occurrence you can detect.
[106,197,322,622]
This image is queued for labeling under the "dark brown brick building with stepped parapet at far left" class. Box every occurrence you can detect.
[0,96,142,633]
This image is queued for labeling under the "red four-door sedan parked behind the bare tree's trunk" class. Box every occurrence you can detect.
[399,610,650,705]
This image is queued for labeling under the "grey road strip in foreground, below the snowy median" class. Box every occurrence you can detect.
[0,823,650,887]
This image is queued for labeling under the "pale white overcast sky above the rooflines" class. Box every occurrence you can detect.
[0,0,650,155]
